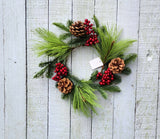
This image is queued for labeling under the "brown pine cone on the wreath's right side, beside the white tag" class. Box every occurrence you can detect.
[108,57,125,74]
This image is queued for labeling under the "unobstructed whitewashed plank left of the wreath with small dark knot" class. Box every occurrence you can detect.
[2,0,26,139]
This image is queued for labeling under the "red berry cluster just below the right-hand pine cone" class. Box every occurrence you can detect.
[99,68,114,85]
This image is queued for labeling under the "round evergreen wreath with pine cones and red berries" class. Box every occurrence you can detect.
[34,15,137,116]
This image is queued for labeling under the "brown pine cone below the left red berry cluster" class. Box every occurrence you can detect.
[58,78,73,94]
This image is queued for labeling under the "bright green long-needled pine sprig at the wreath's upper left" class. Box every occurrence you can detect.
[35,28,72,60]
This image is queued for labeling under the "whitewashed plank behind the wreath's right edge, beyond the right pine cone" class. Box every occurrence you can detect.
[113,0,139,139]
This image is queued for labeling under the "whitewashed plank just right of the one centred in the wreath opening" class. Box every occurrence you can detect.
[92,0,117,139]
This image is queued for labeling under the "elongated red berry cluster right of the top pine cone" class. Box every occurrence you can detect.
[84,19,99,46]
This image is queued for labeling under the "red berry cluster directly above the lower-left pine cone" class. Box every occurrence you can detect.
[52,63,68,81]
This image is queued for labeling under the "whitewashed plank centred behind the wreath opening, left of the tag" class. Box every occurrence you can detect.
[71,0,94,139]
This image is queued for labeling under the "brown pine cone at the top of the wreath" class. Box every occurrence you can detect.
[69,21,85,37]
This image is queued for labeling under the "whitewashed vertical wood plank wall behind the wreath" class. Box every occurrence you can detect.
[0,0,160,139]
